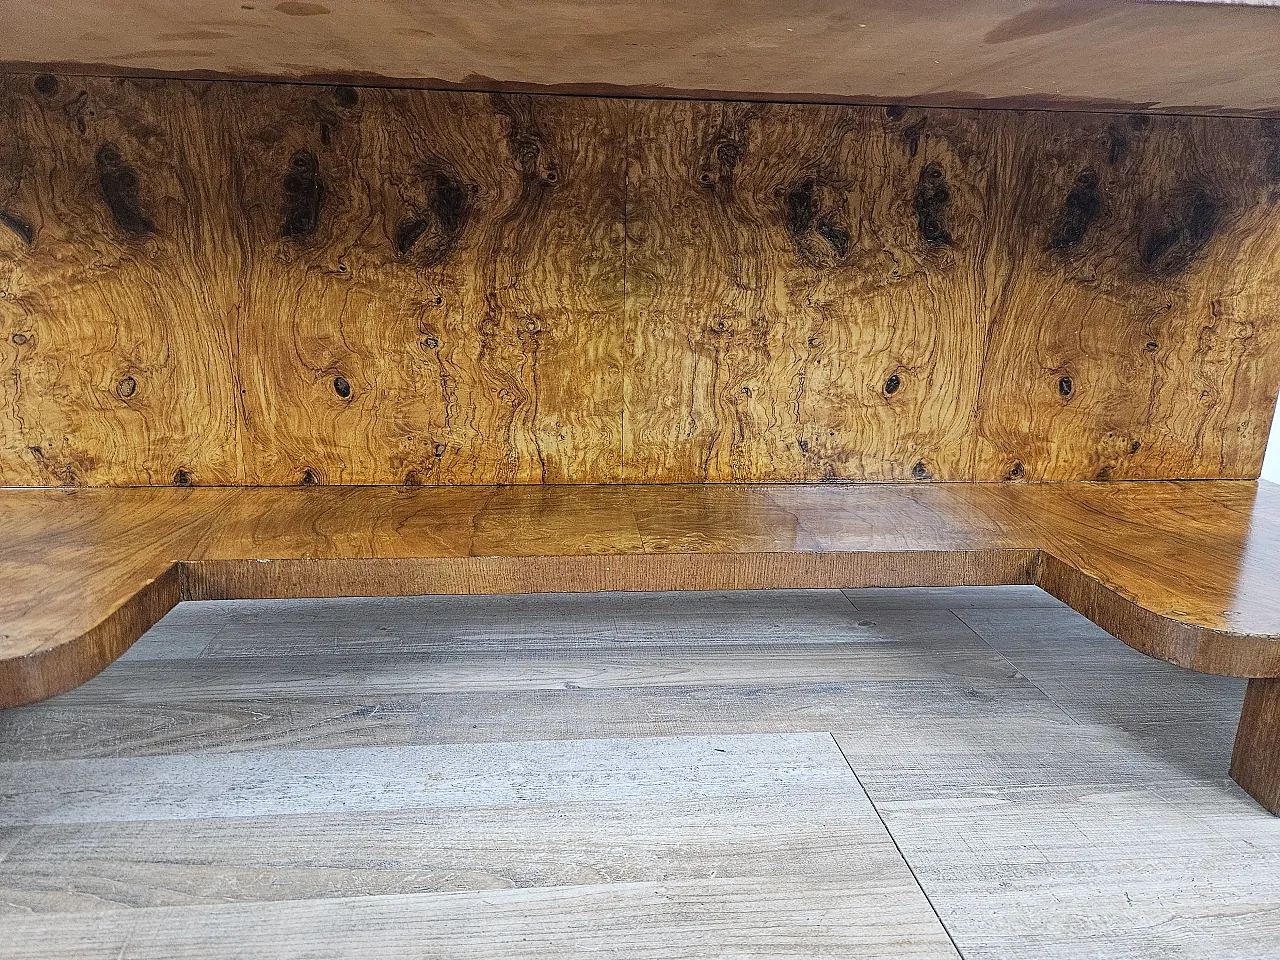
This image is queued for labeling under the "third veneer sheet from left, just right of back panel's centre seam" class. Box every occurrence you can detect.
[627,102,989,481]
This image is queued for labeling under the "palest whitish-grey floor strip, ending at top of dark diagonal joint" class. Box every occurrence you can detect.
[0,733,849,827]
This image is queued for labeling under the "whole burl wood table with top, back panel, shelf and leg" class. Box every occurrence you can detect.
[0,9,1280,813]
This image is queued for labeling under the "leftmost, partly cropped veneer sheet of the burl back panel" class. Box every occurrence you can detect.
[0,77,244,485]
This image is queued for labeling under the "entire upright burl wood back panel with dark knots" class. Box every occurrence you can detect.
[0,76,1280,485]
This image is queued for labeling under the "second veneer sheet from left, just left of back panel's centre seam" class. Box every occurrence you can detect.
[229,87,623,484]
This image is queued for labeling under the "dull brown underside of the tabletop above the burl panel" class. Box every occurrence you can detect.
[0,0,1280,111]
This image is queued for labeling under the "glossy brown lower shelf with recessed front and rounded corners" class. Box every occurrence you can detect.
[0,481,1280,705]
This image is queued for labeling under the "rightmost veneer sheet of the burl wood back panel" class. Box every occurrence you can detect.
[973,115,1280,480]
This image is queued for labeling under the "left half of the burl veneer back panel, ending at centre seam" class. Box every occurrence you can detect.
[0,78,623,484]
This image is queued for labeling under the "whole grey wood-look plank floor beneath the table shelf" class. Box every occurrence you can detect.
[0,588,1280,960]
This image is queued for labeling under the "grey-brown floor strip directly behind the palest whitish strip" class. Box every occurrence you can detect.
[0,680,1064,760]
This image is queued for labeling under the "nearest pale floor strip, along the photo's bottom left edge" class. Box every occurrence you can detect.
[6,870,959,960]
